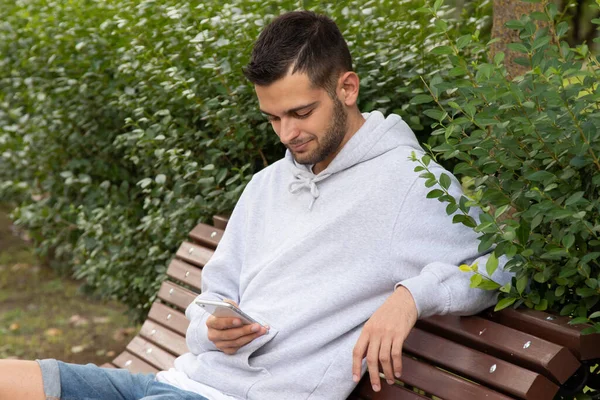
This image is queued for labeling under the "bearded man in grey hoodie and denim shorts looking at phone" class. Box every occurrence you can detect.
[0,12,508,400]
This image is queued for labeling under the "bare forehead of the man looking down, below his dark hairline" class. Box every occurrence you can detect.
[254,73,327,115]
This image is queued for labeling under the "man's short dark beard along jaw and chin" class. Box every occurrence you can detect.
[288,97,348,165]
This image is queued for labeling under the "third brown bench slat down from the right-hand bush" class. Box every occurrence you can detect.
[403,328,558,400]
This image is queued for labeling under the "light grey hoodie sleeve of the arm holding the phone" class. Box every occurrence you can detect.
[185,180,250,354]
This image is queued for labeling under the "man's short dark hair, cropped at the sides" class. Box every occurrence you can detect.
[244,11,352,94]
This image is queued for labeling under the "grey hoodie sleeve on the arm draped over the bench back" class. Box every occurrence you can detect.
[391,163,511,318]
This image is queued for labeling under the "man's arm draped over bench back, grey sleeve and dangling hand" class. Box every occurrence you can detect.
[353,165,510,391]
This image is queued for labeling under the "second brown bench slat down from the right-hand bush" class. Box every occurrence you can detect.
[417,315,581,384]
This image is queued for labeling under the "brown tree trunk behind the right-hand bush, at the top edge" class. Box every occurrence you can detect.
[490,0,544,79]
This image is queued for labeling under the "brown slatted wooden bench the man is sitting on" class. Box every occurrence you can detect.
[105,217,600,400]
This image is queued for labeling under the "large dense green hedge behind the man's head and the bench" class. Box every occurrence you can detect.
[0,0,490,316]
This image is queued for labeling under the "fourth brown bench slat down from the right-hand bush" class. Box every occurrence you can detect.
[400,355,510,400]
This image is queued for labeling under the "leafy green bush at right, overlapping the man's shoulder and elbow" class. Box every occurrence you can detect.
[415,3,600,333]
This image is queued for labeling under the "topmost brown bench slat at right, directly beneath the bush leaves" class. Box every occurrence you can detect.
[485,308,600,361]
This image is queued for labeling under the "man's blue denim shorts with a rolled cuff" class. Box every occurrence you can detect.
[38,359,208,400]
